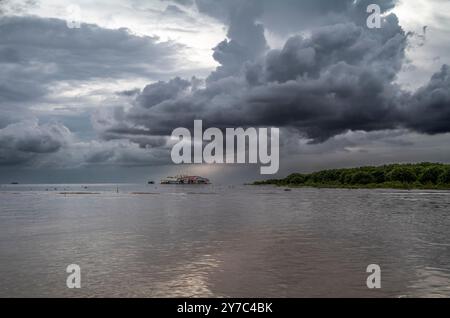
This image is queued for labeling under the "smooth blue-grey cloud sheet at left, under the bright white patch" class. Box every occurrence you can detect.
[0,17,182,101]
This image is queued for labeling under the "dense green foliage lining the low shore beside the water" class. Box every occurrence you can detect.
[254,163,450,189]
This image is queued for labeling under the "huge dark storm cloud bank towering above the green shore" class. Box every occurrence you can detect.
[102,0,450,147]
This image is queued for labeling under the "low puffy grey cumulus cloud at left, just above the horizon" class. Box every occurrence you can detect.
[0,119,170,168]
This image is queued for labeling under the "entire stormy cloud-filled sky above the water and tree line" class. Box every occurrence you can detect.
[0,0,450,183]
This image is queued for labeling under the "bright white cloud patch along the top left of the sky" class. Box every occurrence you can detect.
[4,0,226,69]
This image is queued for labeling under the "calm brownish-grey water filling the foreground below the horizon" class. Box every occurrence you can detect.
[0,185,450,297]
